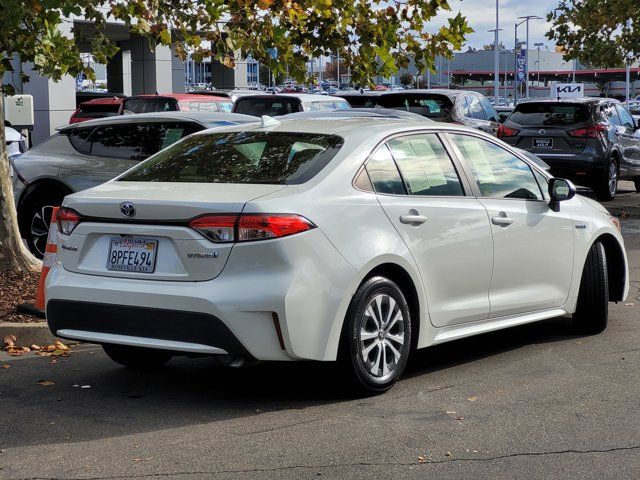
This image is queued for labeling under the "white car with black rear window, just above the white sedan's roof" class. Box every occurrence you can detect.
[233,93,350,117]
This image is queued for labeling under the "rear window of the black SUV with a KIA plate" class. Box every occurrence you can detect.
[509,103,589,126]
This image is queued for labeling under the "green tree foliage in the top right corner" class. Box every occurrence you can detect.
[547,0,640,68]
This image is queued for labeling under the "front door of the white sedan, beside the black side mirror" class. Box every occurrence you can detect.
[449,132,574,318]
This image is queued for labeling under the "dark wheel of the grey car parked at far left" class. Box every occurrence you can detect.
[19,190,70,259]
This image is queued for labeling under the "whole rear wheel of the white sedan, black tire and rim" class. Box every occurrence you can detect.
[340,277,411,394]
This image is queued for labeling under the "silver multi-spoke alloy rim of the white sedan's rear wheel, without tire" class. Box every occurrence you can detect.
[360,293,405,378]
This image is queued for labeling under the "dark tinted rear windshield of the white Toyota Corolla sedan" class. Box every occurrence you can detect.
[120,132,343,185]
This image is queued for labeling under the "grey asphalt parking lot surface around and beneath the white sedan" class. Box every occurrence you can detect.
[0,220,640,479]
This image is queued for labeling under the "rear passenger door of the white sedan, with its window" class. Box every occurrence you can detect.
[367,133,493,327]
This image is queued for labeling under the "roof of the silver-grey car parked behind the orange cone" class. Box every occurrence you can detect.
[57,111,259,132]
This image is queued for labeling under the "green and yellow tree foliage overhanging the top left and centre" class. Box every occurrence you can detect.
[0,0,473,92]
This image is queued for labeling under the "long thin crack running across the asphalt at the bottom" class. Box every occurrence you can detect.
[19,445,640,480]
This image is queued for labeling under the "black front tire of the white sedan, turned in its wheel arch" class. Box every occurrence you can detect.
[573,242,609,334]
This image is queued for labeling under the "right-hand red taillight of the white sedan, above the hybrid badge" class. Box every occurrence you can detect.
[189,213,316,243]
